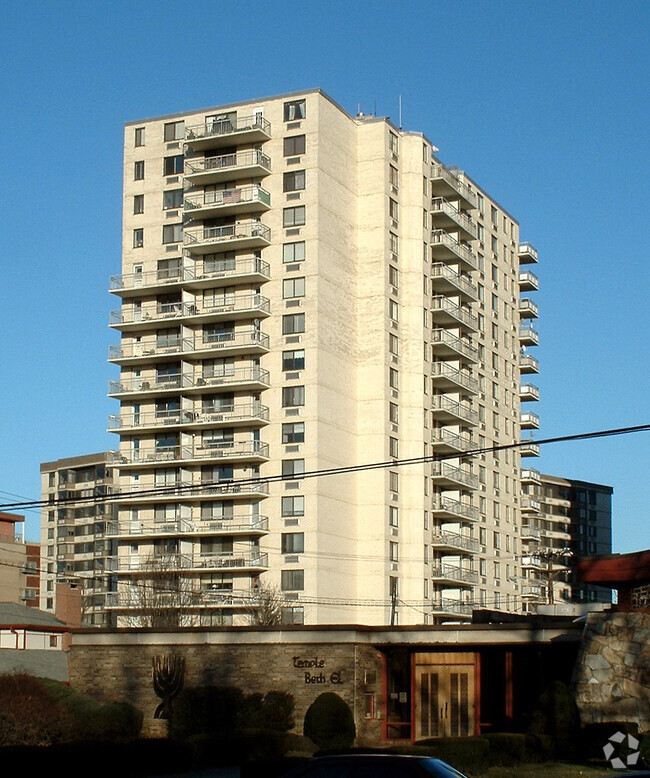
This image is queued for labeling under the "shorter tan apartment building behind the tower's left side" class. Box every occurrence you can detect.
[40,452,117,627]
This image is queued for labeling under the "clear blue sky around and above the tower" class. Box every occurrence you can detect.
[0,0,650,552]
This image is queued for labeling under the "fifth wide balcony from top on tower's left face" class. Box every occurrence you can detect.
[108,403,269,432]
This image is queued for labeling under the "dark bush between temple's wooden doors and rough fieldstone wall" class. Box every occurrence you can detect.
[528,681,580,759]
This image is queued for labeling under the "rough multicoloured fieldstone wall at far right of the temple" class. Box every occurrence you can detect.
[574,611,650,732]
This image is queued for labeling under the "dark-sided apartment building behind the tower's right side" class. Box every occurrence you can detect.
[521,469,613,612]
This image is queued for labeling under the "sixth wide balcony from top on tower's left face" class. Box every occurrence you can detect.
[108,440,269,467]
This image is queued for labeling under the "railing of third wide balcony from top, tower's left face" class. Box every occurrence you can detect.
[108,328,269,362]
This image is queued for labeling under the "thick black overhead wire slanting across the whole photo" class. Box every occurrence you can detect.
[0,424,650,510]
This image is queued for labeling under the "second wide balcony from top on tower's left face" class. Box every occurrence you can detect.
[110,293,271,330]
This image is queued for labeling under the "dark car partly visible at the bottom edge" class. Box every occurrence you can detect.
[283,754,466,778]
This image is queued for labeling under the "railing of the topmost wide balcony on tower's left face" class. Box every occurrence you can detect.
[110,257,271,293]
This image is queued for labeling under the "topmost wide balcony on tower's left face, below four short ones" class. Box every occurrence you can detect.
[110,256,271,297]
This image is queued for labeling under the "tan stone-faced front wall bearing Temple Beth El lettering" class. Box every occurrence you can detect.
[70,635,382,745]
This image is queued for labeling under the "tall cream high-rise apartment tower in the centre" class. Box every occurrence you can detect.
[109,90,538,624]
